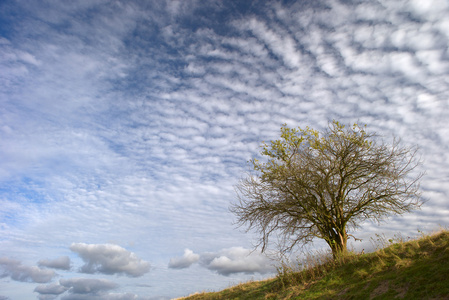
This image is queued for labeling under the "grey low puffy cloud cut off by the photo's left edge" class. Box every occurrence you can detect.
[0,257,56,283]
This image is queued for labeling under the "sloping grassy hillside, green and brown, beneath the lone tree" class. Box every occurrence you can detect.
[178,230,449,300]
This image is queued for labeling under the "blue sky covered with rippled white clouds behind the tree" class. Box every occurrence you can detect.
[0,0,449,300]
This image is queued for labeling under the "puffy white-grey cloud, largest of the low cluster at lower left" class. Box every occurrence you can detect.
[70,243,150,277]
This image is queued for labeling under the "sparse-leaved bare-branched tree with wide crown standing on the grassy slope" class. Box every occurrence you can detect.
[230,121,423,258]
